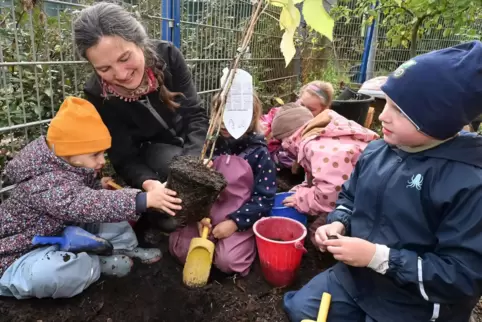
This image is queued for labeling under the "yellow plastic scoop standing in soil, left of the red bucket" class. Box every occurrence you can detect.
[182,219,215,288]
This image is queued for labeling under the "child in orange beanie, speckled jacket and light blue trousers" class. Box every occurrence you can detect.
[0,97,181,299]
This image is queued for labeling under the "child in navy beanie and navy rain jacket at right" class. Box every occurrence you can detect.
[284,41,482,322]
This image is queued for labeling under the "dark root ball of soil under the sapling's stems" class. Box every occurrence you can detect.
[166,156,226,225]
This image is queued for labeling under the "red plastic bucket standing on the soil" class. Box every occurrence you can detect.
[253,217,307,287]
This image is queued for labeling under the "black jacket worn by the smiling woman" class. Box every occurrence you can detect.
[84,41,208,188]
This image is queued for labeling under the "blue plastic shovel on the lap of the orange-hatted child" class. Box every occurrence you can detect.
[32,226,114,255]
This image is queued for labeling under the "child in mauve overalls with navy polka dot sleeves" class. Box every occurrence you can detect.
[169,96,276,276]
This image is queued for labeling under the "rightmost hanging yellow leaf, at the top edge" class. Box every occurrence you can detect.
[303,0,335,41]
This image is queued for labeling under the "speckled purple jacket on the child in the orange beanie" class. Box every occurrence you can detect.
[0,137,140,276]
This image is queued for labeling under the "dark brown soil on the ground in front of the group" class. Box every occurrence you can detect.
[0,233,336,322]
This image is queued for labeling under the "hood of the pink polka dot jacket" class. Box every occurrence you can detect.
[282,110,379,156]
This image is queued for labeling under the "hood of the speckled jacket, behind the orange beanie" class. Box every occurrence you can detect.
[5,136,94,184]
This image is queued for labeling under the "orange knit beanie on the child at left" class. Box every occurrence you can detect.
[47,97,112,157]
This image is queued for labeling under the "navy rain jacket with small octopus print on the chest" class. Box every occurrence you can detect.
[328,133,482,322]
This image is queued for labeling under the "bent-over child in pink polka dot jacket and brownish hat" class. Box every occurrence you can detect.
[272,90,379,220]
